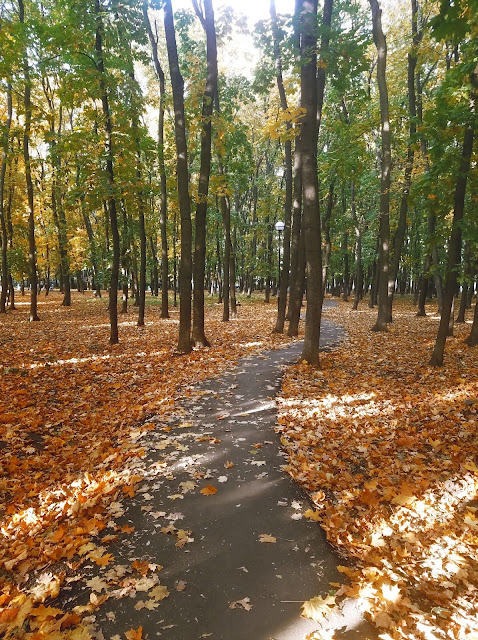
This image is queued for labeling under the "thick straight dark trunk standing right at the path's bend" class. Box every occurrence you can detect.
[300,0,324,366]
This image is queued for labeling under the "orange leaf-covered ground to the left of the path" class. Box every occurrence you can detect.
[0,293,294,640]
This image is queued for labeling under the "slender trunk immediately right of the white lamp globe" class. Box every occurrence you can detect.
[270,0,292,333]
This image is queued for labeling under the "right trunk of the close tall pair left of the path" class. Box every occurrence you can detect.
[192,0,217,347]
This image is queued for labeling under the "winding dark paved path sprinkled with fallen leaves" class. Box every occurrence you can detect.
[64,312,378,640]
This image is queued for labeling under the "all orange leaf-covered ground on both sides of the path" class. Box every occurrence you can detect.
[0,293,478,640]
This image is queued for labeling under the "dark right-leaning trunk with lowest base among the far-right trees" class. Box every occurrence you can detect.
[430,65,478,367]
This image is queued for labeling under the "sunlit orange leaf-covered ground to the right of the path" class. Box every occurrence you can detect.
[279,301,478,640]
